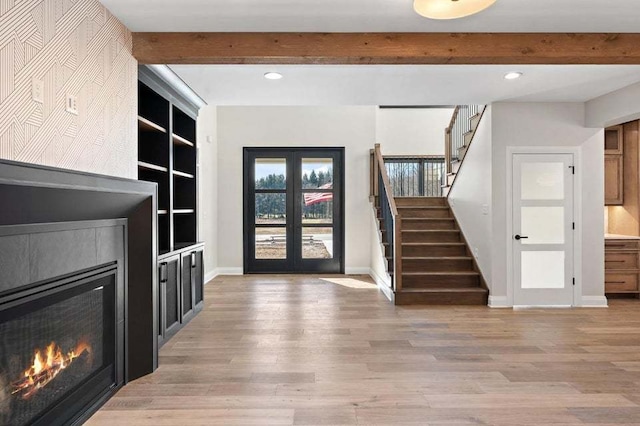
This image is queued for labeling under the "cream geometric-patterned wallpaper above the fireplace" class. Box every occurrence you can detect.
[0,0,138,179]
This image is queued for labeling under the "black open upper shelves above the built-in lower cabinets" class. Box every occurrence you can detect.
[138,67,198,254]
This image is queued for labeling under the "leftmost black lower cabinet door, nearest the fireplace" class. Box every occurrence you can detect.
[158,256,181,342]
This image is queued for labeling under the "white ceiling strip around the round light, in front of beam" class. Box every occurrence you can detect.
[101,0,640,32]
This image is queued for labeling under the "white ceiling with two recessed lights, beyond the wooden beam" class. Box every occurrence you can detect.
[171,65,640,105]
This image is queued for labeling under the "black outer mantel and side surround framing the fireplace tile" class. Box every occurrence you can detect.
[0,160,159,422]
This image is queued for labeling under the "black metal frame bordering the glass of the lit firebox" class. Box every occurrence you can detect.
[0,262,125,426]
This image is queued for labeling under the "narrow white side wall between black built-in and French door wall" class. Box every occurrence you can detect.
[197,106,218,280]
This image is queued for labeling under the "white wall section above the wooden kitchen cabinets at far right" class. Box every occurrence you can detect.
[585,83,640,127]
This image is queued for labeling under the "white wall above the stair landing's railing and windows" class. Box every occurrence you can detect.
[376,108,453,155]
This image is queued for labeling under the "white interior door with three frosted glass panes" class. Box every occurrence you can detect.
[512,154,574,306]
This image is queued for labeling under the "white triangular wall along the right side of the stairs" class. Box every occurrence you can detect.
[449,106,492,290]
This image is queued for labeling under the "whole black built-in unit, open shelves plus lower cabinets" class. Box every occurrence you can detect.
[138,66,204,346]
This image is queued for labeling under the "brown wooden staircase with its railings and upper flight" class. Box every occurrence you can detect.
[370,105,489,306]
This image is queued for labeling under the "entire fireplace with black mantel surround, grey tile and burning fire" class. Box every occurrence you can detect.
[0,160,158,425]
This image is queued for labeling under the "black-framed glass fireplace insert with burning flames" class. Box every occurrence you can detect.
[0,265,117,426]
